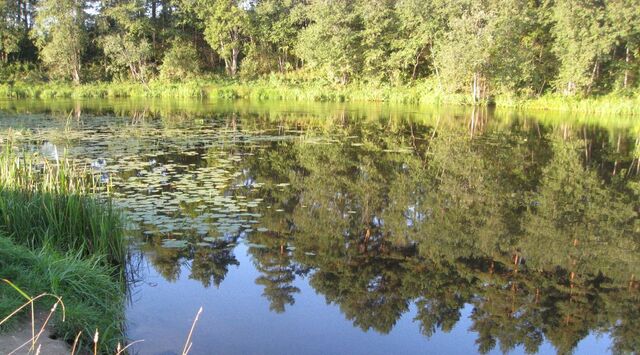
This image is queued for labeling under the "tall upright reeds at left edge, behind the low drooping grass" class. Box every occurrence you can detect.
[0,142,126,266]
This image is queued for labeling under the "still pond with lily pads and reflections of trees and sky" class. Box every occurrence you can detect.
[0,100,640,354]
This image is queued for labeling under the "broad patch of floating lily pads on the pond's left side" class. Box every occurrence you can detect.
[0,116,295,248]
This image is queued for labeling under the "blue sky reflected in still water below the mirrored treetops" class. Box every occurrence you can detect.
[127,244,610,355]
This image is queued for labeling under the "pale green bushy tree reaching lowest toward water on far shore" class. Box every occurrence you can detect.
[434,1,544,101]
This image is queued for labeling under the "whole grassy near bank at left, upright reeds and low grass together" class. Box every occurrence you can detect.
[0,141,126,352]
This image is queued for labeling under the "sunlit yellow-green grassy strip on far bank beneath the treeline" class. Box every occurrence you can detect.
[0,80,640,115]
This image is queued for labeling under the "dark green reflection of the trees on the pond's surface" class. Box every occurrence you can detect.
[7,102,640,353]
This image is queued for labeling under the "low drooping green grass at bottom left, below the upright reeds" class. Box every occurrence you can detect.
[0,233,124,354]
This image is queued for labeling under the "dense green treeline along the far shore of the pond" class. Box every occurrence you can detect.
[0,0,640,101]
